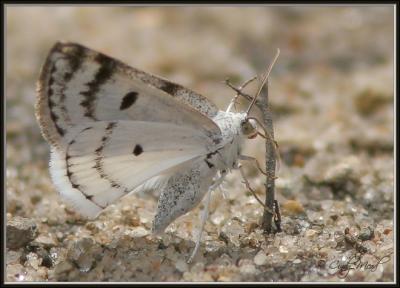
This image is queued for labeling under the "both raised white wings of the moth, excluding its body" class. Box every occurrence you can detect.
[36,42,225,217]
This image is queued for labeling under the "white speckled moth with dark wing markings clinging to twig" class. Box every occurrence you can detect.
[35,42,278,260]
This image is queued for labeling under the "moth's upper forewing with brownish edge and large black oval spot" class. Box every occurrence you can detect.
[36,43,220,149]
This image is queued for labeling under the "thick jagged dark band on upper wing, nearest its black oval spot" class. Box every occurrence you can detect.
[80,53,117,120]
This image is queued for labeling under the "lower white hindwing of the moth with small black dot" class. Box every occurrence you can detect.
[50,120,213,218]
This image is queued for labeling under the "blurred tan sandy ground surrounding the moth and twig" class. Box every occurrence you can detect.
[5,6,394,282]
